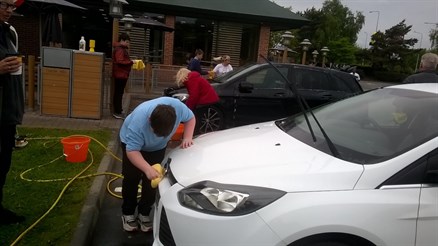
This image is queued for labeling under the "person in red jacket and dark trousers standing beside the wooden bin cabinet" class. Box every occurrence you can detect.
[113,33,134,119]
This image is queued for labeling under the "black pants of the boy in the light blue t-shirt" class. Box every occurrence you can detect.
[122,143,166,216]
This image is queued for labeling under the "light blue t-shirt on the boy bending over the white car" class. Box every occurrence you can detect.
[120,97,194,152]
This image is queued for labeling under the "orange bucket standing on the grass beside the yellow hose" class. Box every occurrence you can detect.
[61,136,91,162]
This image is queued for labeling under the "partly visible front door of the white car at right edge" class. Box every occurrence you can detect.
[415,150,438,246]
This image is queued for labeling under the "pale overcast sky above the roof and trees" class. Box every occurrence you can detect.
[271,0,438,49]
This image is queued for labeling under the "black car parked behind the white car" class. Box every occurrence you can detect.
[164,63,363,133]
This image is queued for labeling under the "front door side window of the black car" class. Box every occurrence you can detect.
[243,67,288,89]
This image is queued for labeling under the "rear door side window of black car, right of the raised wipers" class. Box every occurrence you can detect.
[294,68,338,91]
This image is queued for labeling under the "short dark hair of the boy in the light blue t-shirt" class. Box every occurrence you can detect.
[150,104,176,137]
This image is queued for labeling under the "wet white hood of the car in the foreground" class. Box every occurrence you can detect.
[165,122,363,192]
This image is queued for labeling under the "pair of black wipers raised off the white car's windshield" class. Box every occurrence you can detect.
[260,55,340,158]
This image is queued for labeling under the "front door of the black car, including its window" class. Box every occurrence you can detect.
[234,66,291,126]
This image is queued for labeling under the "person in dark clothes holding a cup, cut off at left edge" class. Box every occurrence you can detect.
[0,0,24,225]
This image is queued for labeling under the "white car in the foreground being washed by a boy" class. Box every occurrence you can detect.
[153,83,438,246]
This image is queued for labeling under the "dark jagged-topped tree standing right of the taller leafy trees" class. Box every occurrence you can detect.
[370,20,418,72]
